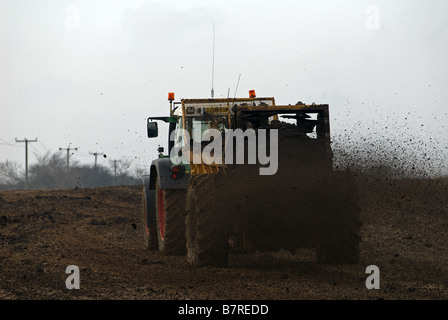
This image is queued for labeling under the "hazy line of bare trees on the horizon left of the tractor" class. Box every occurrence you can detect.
[0,153,140,190]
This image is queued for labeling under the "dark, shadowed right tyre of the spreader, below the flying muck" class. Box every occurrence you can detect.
[316,173,361,264]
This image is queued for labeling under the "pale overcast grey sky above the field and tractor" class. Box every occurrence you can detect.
[0,0,448,173]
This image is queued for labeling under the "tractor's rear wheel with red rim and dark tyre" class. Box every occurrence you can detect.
[155,181,187,255]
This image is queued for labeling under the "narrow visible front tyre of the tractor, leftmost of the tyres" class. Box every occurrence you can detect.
[142,187,159,250]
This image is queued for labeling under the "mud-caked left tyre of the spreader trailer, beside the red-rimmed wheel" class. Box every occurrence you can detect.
[186,175,231,267]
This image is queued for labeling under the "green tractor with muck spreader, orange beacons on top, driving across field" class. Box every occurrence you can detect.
[142,90,361,267]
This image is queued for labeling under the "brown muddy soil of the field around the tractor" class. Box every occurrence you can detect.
[0,179,448,300]
